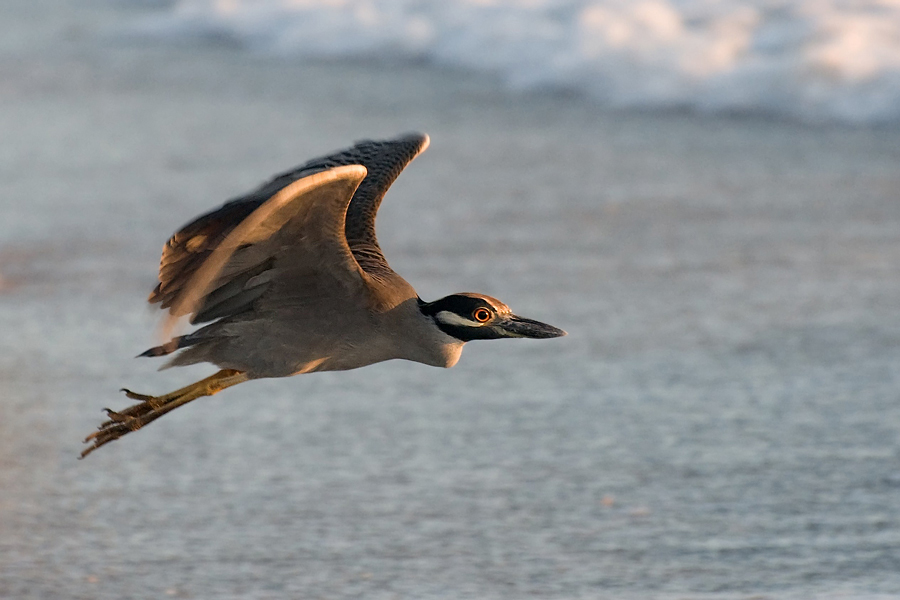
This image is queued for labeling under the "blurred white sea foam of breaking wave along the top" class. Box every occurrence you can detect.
[134,0,900,123]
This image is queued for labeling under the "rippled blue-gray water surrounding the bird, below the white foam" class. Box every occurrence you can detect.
[0,0,900,599]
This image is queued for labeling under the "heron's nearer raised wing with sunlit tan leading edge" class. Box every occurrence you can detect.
[156,165,368,337]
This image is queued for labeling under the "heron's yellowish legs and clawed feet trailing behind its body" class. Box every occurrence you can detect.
[81,369,249,458]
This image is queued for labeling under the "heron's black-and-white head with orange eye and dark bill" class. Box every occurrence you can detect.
[419,293,566,342]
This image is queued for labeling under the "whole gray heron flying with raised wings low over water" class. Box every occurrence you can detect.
[82,134,565,457]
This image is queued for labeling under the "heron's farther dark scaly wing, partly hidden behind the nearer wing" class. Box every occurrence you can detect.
[149,133,428,310]
